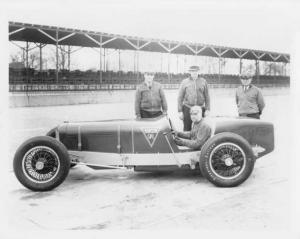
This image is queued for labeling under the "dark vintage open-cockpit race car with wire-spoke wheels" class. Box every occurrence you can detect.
[13,117,274,191]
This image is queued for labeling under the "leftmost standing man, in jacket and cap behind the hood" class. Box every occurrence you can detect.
[135,72,168,119]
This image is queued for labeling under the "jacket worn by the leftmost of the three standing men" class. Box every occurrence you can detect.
[135,81,168,116]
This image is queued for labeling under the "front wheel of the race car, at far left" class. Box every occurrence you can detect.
[13,136,70,191]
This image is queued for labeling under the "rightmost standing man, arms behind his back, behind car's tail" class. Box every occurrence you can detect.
[235,70,265,119]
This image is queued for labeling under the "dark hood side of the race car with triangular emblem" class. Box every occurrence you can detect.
[55,118,179,154]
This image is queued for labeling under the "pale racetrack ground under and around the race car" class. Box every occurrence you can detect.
[6,89,291,231]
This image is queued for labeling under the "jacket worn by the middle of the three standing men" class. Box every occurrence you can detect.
[178,77,210,112]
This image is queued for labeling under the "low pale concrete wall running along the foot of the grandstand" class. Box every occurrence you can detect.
[9,87,289,107]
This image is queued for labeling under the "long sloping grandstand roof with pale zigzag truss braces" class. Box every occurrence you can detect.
[9,22,290,63]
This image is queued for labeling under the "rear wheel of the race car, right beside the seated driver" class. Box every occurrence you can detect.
[199,132,255,187]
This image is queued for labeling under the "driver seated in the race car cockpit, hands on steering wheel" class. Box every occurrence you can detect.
[172,105,211,150]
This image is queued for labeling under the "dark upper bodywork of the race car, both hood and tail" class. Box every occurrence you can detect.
[48,117,274,161]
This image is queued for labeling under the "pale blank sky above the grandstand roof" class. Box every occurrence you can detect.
[2,0,300,53]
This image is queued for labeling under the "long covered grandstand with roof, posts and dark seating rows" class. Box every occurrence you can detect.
[9,22,290,92]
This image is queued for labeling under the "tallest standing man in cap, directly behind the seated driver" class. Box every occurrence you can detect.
[178,66,210,131]
